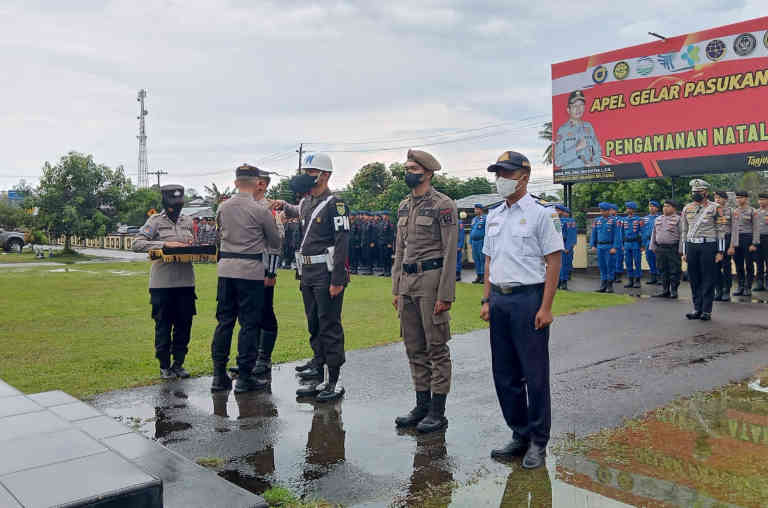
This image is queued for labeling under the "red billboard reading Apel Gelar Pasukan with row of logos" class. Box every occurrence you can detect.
[552,17,768,183]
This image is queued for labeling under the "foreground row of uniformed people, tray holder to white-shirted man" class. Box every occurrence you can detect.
[133,150,563,468]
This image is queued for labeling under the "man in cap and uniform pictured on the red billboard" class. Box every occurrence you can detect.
[555,90,601,169]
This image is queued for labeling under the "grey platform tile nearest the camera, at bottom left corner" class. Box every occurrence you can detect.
[0,451,162,508]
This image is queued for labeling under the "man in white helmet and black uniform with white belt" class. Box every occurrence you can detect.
[272,153,350,402]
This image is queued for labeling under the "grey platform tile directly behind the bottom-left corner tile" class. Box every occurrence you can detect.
[0,428,107,476]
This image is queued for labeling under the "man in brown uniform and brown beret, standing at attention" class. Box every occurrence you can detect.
[392,150,459,432]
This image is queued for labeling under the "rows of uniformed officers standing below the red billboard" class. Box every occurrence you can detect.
[590,179,768,321]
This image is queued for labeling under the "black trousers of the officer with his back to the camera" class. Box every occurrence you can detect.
[211,277,264,372]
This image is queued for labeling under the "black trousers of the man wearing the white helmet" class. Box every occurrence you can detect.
[300,265,345,367]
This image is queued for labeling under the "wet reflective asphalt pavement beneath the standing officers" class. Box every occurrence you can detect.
[92,292,768,506]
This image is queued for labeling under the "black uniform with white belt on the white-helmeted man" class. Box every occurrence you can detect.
[285,191,350,374]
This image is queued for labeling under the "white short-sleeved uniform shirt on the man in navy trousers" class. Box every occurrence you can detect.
[483,194,563,287]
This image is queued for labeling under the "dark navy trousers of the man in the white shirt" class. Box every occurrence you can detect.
[491,284,552,446]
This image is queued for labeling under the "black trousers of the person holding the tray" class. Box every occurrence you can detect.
[149,287,197,369]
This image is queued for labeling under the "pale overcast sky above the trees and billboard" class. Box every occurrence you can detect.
[0,0,768,191]
